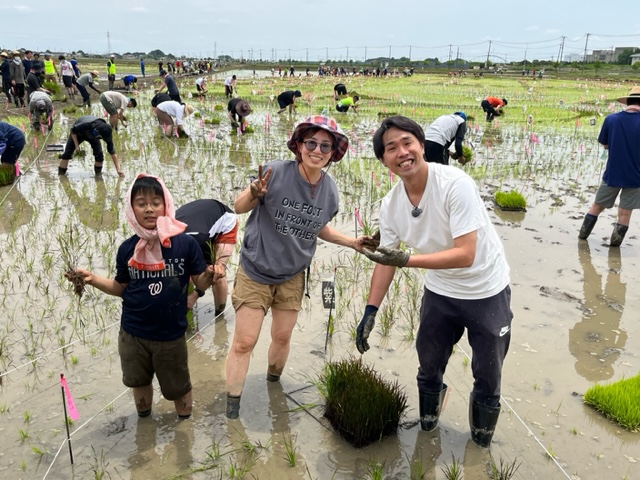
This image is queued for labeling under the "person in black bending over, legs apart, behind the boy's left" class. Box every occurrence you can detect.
[58,115,124,177]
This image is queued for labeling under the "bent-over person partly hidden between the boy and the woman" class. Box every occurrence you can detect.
[176,199,238,317]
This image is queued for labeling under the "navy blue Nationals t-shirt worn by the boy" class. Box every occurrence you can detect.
[115,233,207,342]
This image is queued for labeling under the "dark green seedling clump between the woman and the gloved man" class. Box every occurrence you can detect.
[316,358,407,448]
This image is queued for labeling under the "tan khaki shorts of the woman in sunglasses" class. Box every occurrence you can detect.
[231,266,304,313]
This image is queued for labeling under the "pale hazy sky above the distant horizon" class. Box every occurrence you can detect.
[0,0,640,63]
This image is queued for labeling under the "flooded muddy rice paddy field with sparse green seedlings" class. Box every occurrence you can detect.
[0,70,640,480]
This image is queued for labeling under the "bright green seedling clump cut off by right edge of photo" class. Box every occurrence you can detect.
[584,375,640,432]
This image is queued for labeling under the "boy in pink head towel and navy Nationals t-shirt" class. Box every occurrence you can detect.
[67,173,224,419]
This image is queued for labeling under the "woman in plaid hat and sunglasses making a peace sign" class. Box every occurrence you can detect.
[226,115,364,418]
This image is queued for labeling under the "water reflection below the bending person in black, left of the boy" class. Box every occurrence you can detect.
[60,175,122,231]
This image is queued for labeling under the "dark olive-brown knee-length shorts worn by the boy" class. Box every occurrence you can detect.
[118,328,192,400]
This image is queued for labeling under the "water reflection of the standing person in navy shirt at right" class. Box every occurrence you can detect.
[569,242,627,382]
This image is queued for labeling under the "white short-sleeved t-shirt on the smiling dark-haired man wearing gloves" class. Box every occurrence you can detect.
[380,163,509,300]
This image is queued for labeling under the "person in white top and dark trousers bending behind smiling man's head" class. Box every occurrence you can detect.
[424,112,467,165]
